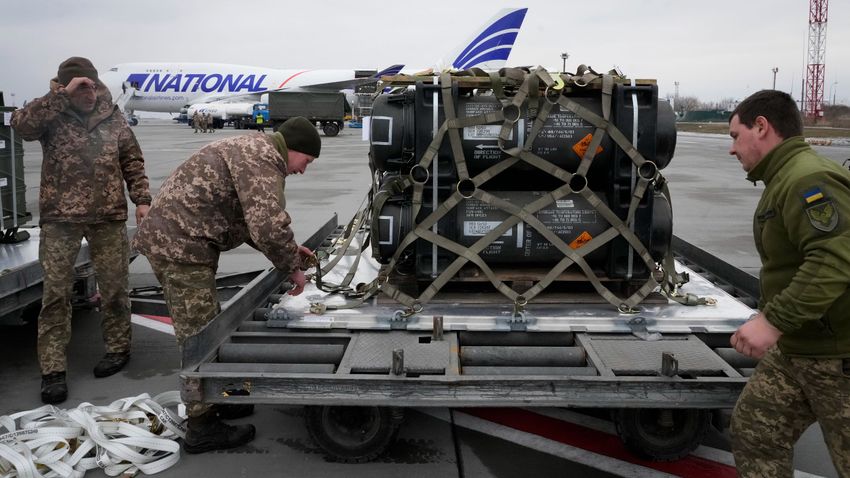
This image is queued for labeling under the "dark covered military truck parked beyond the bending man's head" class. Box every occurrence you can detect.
[268,91,346,136]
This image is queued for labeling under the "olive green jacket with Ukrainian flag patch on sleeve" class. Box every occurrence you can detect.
[747,136,850,358]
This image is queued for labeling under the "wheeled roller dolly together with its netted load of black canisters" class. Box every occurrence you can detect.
[171,68,758,462]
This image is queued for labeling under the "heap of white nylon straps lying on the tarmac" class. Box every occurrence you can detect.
[0,391,186,478]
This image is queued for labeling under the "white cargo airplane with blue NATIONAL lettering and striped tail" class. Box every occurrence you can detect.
[101,8,528,124]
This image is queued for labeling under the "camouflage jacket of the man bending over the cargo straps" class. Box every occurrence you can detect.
[133,134,298,274]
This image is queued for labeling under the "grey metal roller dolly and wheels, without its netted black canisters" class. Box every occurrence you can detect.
[181,217,757,461]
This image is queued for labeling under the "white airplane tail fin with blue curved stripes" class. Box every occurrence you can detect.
[439,8,528,70]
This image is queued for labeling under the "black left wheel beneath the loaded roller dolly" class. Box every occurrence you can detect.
[305,406,404,463]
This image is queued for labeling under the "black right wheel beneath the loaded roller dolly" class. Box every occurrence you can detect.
[614,408,711,461]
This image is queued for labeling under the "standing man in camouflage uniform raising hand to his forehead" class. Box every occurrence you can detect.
[12,57,151,403]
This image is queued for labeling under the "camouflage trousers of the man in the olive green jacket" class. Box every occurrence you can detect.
[731,347,850,478]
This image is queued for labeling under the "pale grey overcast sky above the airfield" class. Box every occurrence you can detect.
[0,0,850,105]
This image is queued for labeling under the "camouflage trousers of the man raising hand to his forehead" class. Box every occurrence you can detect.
[38,221,131,375]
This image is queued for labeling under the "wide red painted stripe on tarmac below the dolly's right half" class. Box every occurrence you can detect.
[459,408,737,478]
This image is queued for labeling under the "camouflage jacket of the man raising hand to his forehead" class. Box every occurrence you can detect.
[12,79,151,224]
